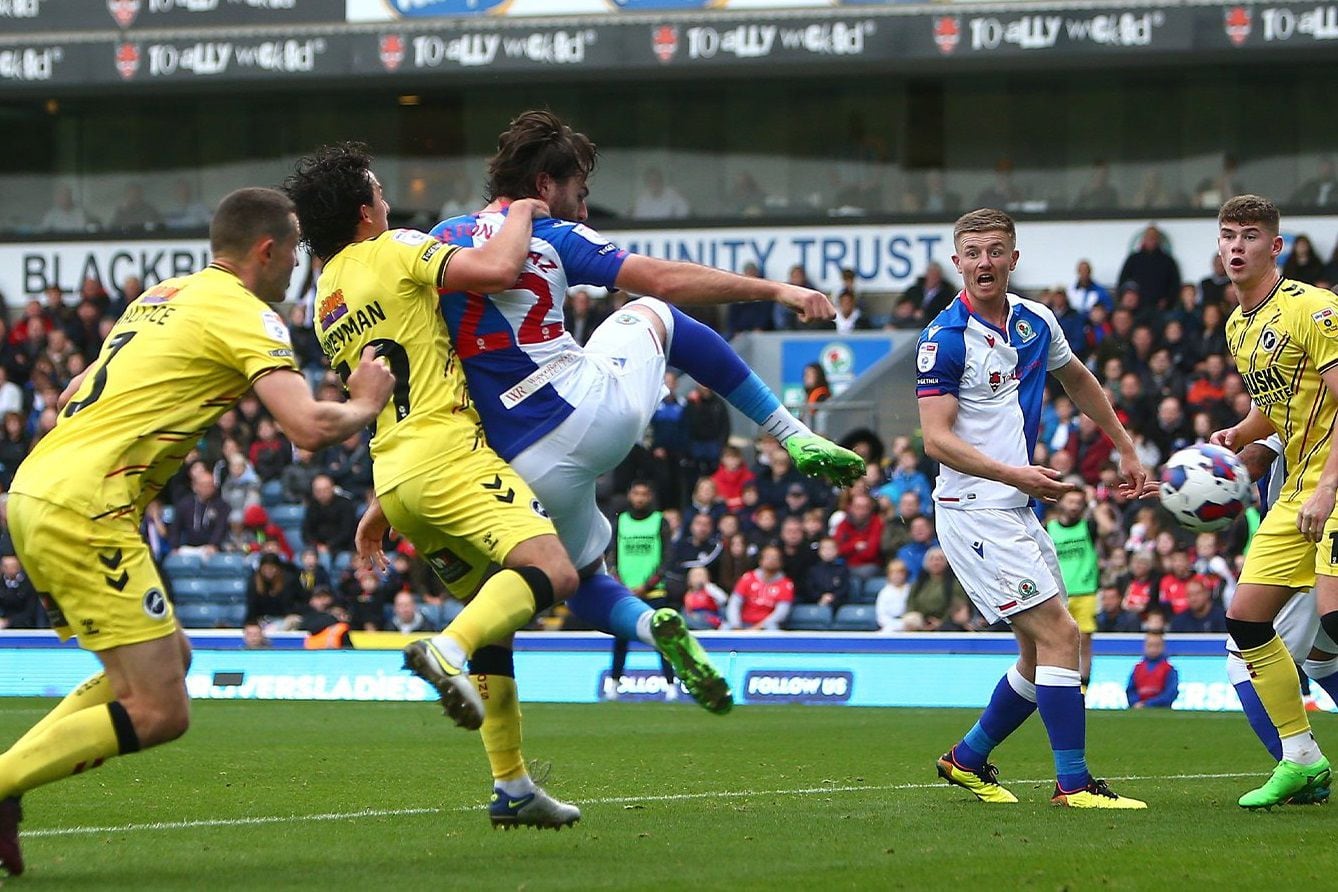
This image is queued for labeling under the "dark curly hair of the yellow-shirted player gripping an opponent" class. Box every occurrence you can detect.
[284,142,373,261]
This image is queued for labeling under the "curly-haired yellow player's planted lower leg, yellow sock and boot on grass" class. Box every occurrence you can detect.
[470,645,581,830]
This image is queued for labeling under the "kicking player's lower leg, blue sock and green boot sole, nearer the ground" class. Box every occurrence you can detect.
[567,572,735,714]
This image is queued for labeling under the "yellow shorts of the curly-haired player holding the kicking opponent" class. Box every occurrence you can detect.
[379,448,558,600]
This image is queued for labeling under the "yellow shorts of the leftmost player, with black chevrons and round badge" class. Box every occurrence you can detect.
[9,492,177,650]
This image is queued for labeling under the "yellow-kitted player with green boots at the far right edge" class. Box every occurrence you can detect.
[1211,195,1338,808]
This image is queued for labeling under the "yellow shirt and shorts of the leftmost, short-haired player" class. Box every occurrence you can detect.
[8,266,297,650]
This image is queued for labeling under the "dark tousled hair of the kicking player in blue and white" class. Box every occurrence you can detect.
[486,110,599,201]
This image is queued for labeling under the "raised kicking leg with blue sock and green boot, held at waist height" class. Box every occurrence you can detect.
[652,298,864,487]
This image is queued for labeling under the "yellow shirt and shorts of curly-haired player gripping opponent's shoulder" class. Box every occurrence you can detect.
[316,230,555,598]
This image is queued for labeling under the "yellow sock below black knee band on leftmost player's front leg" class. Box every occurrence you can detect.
[0,706,120,797]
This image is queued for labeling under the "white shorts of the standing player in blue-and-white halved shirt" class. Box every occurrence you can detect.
[934,506,1064,623]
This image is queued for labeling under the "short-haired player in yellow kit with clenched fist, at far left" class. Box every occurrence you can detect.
[0,189,395,875]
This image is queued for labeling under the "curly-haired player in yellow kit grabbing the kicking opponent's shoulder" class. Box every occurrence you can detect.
[284,143,581,828]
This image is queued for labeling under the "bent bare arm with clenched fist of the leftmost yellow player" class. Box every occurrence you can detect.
[253,346,395,452]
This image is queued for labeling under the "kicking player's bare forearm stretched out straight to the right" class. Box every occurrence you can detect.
[614,254,836,322]
